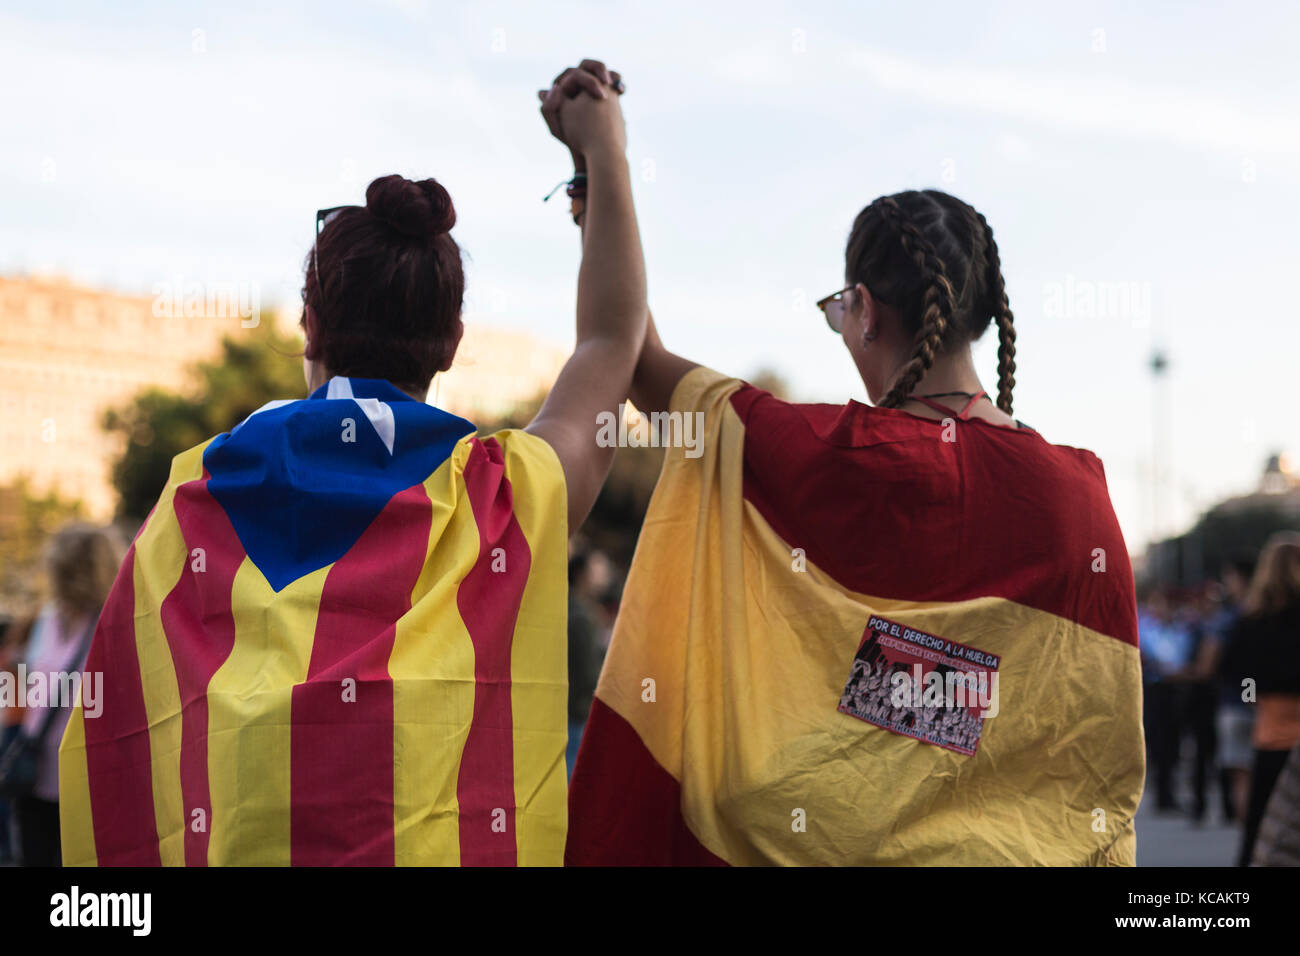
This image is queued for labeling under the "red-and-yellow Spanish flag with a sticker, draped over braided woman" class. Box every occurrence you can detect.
[566,368,1144,865]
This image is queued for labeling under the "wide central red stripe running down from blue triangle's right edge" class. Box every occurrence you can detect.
[290,485,433,866]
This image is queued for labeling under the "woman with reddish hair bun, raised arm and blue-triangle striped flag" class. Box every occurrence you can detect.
[61,61,646,865]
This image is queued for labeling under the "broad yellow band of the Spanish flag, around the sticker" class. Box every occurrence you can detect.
[598,373,1144,865]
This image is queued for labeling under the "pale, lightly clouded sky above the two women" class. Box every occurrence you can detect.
[0,0,1300,550]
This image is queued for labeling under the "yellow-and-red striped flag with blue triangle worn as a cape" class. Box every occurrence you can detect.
[60,377,567,865]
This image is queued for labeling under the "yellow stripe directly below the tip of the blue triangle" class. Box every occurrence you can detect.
[208,558,325,866]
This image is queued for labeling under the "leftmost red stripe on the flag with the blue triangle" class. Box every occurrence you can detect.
[85,545,163,866]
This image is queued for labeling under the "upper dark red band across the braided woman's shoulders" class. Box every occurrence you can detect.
[732,386,1138,645]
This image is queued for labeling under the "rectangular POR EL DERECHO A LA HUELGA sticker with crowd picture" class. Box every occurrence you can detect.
[839,615,1001,756]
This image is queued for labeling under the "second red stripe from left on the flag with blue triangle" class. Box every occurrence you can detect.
[160,470,244,866]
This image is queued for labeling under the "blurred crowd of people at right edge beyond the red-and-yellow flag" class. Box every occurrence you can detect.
[1139,532,1300,866]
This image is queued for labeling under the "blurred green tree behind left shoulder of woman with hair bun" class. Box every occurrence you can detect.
[104,317,306,523]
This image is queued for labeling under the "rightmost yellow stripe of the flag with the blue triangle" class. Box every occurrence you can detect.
[494,431,568,866]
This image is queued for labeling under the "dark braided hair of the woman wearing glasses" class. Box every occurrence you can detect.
[845,190,1015,415]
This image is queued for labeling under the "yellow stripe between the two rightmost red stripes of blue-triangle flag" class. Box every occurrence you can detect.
[389,442,478,866]
